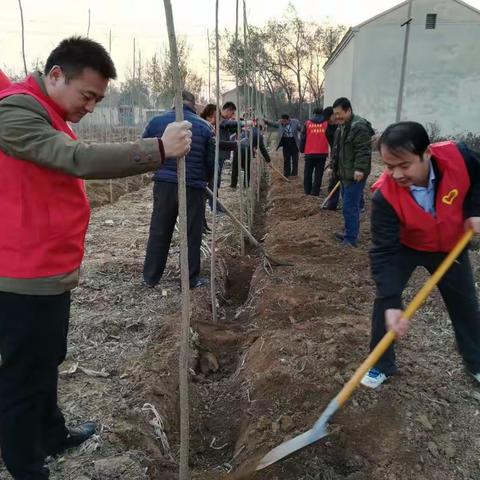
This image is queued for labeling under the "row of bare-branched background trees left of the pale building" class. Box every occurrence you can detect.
[115,4,346,118]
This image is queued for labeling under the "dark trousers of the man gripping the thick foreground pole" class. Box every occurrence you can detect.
[0,292,70,480]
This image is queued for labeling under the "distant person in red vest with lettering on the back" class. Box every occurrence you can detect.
[300,108,328,197]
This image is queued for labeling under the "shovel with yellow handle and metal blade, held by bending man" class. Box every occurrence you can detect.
[255,229,473,470]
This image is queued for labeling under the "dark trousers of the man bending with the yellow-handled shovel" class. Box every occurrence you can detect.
[370,247,480,375]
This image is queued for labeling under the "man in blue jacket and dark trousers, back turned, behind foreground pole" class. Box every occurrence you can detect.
[143,92,215,288]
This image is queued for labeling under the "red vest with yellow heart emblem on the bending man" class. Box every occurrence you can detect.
[372,142,470,252]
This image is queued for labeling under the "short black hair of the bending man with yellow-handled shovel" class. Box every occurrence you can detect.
[378,122,430,157]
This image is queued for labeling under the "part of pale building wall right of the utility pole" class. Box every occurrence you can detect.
[402,0,480,134]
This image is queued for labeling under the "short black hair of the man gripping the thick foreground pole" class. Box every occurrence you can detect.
[44,36,117,81]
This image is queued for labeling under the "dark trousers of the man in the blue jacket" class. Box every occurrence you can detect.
[143,182,205,285]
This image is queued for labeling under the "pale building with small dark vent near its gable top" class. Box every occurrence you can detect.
[325,0,480,134]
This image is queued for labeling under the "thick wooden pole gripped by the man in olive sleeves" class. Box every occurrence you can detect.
[163,0,190,480]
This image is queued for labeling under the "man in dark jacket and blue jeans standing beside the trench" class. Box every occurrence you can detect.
[333,98,375,247]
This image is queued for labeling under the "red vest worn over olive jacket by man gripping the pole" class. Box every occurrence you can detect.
[0,76,90,278]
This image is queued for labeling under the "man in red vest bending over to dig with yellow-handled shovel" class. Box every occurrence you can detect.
[362,122,480,388]
